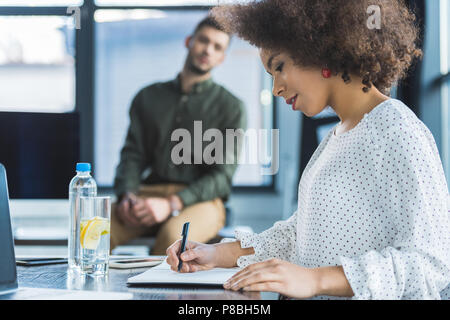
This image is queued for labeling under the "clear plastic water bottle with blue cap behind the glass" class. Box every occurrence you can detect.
[68,163,97,270]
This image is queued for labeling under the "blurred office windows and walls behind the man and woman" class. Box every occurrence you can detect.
[0,0,450,252]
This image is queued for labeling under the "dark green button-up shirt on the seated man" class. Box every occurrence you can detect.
[114,76,246,206]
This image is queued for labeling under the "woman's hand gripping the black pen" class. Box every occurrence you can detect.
[166,240,218,272]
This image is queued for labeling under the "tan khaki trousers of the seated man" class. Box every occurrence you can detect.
[110,184,225,255]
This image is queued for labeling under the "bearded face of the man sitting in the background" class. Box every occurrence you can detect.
[186,26,230,75]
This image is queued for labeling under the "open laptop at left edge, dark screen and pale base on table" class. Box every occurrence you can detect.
[0,163,133,300]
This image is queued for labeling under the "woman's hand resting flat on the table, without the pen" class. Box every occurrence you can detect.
[224,259,319,299]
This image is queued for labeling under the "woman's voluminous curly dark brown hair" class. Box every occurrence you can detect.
[210,0,423,94]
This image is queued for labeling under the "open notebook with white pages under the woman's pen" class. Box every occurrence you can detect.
[127,261,240,286]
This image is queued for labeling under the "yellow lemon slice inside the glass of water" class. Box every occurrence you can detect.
[80,217,109,250]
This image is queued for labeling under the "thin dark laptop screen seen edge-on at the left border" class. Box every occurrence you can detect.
[0,163,17,293]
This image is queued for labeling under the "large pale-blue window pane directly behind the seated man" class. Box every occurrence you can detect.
[94,9,273,186]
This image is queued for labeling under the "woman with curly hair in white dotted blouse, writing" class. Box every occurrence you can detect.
[167,0,450,299]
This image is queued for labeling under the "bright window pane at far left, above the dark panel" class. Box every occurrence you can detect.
[0,16,75,112]
